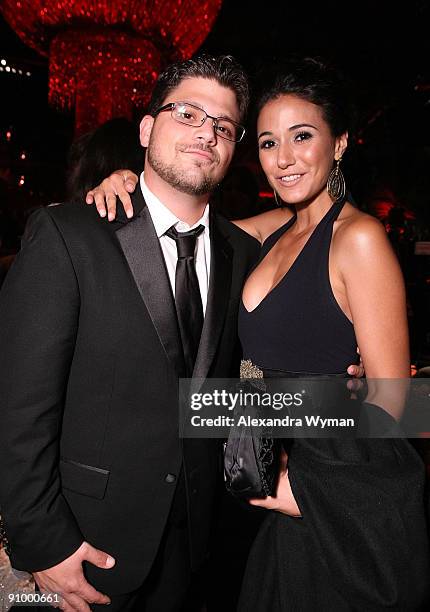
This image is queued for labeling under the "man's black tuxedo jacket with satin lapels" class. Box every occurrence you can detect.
[0,189,259,594]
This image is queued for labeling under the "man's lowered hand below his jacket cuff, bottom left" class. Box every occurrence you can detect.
[33,542,115,612]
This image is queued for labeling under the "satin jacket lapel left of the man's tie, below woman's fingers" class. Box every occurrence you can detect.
[116,187,184,376]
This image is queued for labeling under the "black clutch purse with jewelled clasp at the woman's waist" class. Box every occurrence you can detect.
[224,361,281,499]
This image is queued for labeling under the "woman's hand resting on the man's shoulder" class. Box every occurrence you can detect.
[85,170,139,221]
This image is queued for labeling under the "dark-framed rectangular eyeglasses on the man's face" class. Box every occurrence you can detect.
[154,102,245,142]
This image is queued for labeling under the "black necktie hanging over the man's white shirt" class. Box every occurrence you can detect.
[166,225,205,377]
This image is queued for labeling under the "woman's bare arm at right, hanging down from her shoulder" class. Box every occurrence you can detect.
[334,215,410,418]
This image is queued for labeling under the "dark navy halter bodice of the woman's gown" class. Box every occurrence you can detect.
[239,201,357,374]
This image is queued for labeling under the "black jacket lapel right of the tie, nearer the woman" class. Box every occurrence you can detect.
[193,215,233,378]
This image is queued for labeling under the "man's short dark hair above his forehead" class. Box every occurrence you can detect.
[147,54,249,120]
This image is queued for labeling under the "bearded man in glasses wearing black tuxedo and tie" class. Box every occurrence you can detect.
[0,56,258,612]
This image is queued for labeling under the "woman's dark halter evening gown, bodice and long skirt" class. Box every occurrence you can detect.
[239,202,430,612]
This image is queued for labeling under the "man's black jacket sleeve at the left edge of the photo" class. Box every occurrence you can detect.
[0,209,83,572]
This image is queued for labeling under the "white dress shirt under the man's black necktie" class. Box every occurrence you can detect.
[140,172,211,313]
